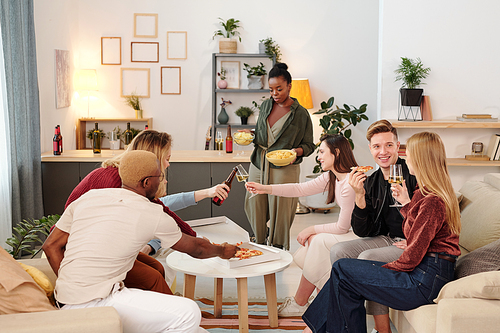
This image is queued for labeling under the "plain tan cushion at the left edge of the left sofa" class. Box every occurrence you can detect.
[0,248,55,314]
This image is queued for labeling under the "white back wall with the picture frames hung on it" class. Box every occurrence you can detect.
[35,0,378,182]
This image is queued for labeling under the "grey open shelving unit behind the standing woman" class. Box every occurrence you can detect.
[212,53,276,149]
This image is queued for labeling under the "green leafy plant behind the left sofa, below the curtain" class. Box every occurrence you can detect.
[5,214,61,259]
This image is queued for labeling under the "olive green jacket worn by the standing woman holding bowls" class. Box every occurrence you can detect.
[250,97,315,169]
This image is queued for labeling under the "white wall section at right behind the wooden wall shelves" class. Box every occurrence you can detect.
[380,0,500,189]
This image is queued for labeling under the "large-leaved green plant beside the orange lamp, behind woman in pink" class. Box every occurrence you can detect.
[313,97,368,173]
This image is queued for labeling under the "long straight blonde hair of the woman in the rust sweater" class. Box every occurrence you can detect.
[406,132,461,235]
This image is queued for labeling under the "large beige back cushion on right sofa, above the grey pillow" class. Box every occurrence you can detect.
[460,174,500,252]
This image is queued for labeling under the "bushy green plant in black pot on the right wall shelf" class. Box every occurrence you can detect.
[394,57,431,106]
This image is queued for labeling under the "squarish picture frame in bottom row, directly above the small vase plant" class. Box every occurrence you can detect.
[120,68,150,98]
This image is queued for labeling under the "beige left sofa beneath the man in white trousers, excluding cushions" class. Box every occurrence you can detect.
[0,258,123,333]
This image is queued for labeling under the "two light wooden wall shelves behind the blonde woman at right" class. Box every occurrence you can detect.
[389,119,500,167]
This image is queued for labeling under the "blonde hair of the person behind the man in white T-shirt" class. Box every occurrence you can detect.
[101,130,172,170]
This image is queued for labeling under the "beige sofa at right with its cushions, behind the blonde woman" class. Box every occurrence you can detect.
[390,173,500,333]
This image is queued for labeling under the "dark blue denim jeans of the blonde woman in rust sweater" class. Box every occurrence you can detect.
[302,256,455,333]
